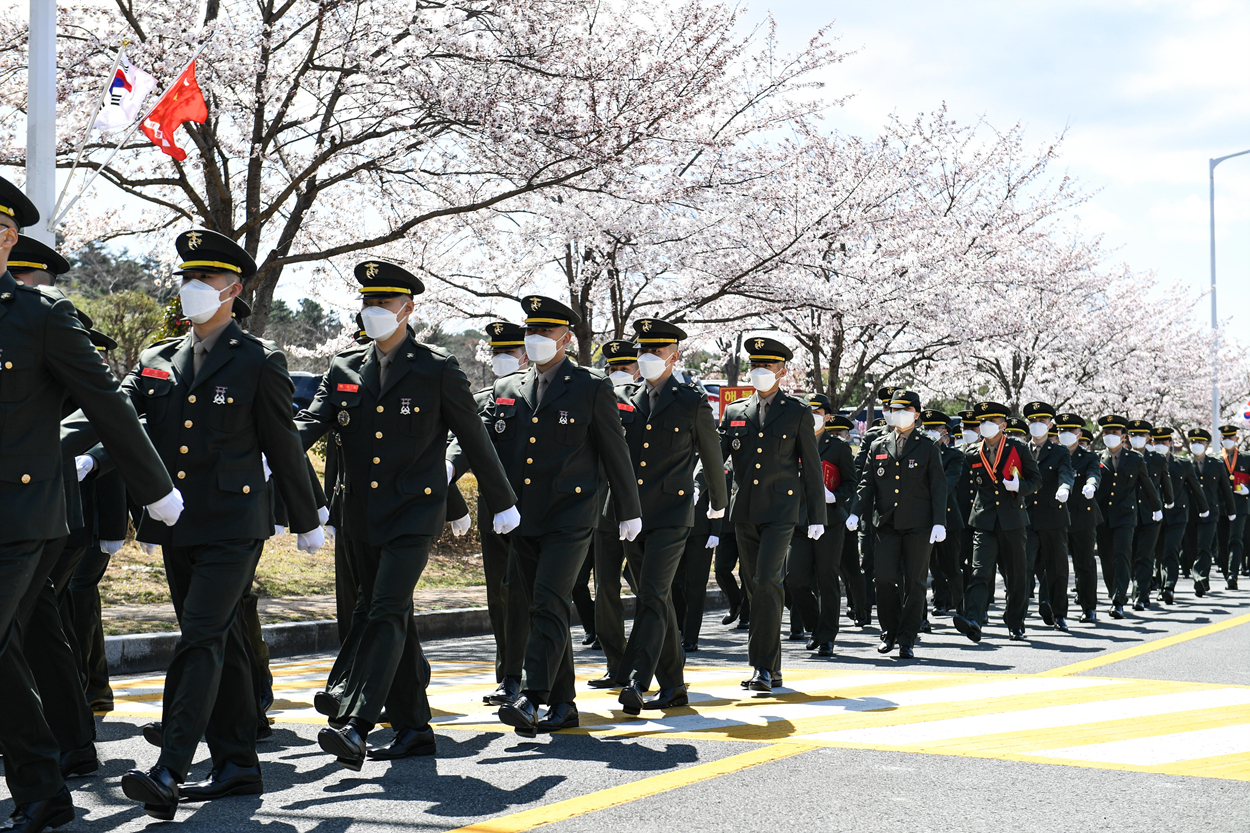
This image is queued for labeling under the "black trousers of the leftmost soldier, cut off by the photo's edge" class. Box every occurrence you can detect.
[0,540,65,804]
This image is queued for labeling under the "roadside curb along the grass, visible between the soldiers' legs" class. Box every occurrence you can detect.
[104,589,729,675]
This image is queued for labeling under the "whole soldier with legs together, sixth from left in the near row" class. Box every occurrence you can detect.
[720,336,825,692]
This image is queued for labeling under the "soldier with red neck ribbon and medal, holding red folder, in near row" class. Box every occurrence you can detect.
[955,401,1041,642]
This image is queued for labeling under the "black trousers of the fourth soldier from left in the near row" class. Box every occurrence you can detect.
[513,527,595,704]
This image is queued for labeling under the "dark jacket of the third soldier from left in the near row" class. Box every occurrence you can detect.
[295,334,516,547]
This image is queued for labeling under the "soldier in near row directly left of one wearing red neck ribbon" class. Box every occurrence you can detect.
[846,389,946,659]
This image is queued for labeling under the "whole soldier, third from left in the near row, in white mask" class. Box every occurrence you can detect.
[296,260,518,772]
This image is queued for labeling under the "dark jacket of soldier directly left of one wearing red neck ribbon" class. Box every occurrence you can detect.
[851,429,948,530]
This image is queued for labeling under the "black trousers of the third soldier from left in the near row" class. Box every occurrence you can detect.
[330,535,435,729]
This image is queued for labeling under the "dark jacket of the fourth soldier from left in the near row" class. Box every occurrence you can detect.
[474,359,643,535]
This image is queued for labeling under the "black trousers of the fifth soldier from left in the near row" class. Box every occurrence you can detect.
[616,527,690,692]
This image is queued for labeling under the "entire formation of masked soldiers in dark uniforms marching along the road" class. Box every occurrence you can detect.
[0,171,1250,833]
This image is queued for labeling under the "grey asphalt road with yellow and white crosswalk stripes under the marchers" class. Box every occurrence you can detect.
[0,580,1250,833]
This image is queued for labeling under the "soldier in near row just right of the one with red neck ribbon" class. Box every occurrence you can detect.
[1024,401,1076,630]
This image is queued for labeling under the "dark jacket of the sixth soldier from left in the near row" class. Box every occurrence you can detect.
[720,390,826,525]
